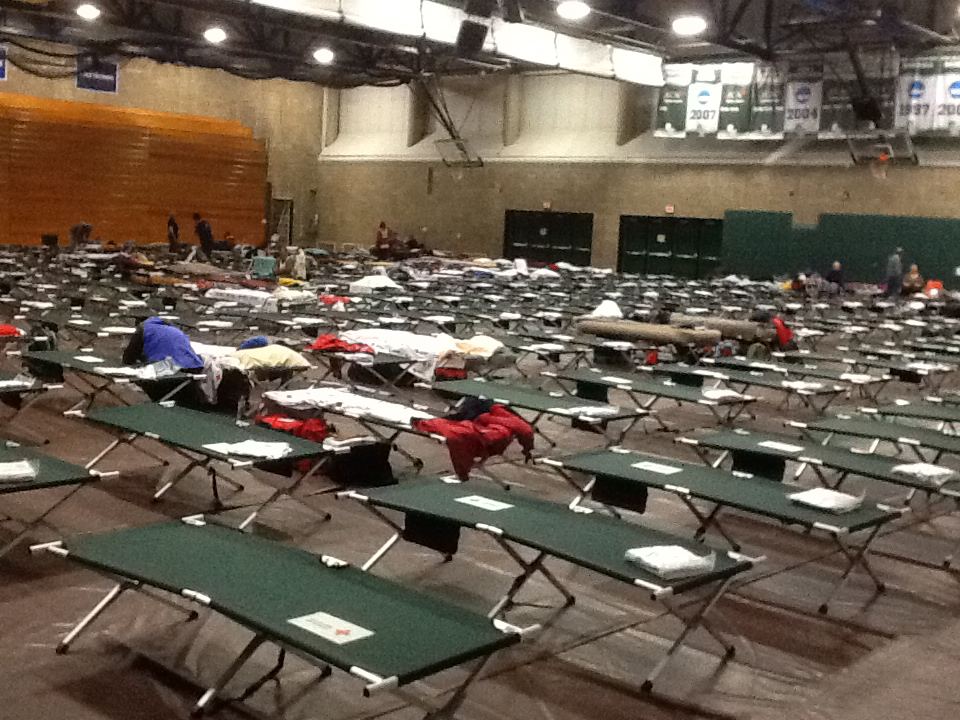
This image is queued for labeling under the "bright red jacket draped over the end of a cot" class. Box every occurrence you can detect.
[413,405,533,481]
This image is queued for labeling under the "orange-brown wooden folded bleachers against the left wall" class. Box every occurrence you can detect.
[0,94,266,245]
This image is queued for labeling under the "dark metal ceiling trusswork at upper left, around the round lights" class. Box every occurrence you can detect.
[0,0,511,87]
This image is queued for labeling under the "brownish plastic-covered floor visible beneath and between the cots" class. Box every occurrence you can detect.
[0,366,960,720]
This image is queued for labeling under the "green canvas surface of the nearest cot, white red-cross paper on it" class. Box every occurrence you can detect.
[64,522,519,684]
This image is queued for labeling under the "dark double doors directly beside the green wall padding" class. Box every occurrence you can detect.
[617,215,723,278]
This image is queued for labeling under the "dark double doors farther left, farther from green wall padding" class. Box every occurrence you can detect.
[503,210,593,266]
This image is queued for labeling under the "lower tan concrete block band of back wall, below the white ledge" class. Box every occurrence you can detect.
[318,160,960,267]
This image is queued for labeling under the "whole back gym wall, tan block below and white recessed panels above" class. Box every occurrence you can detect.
[318,74,960,271]
